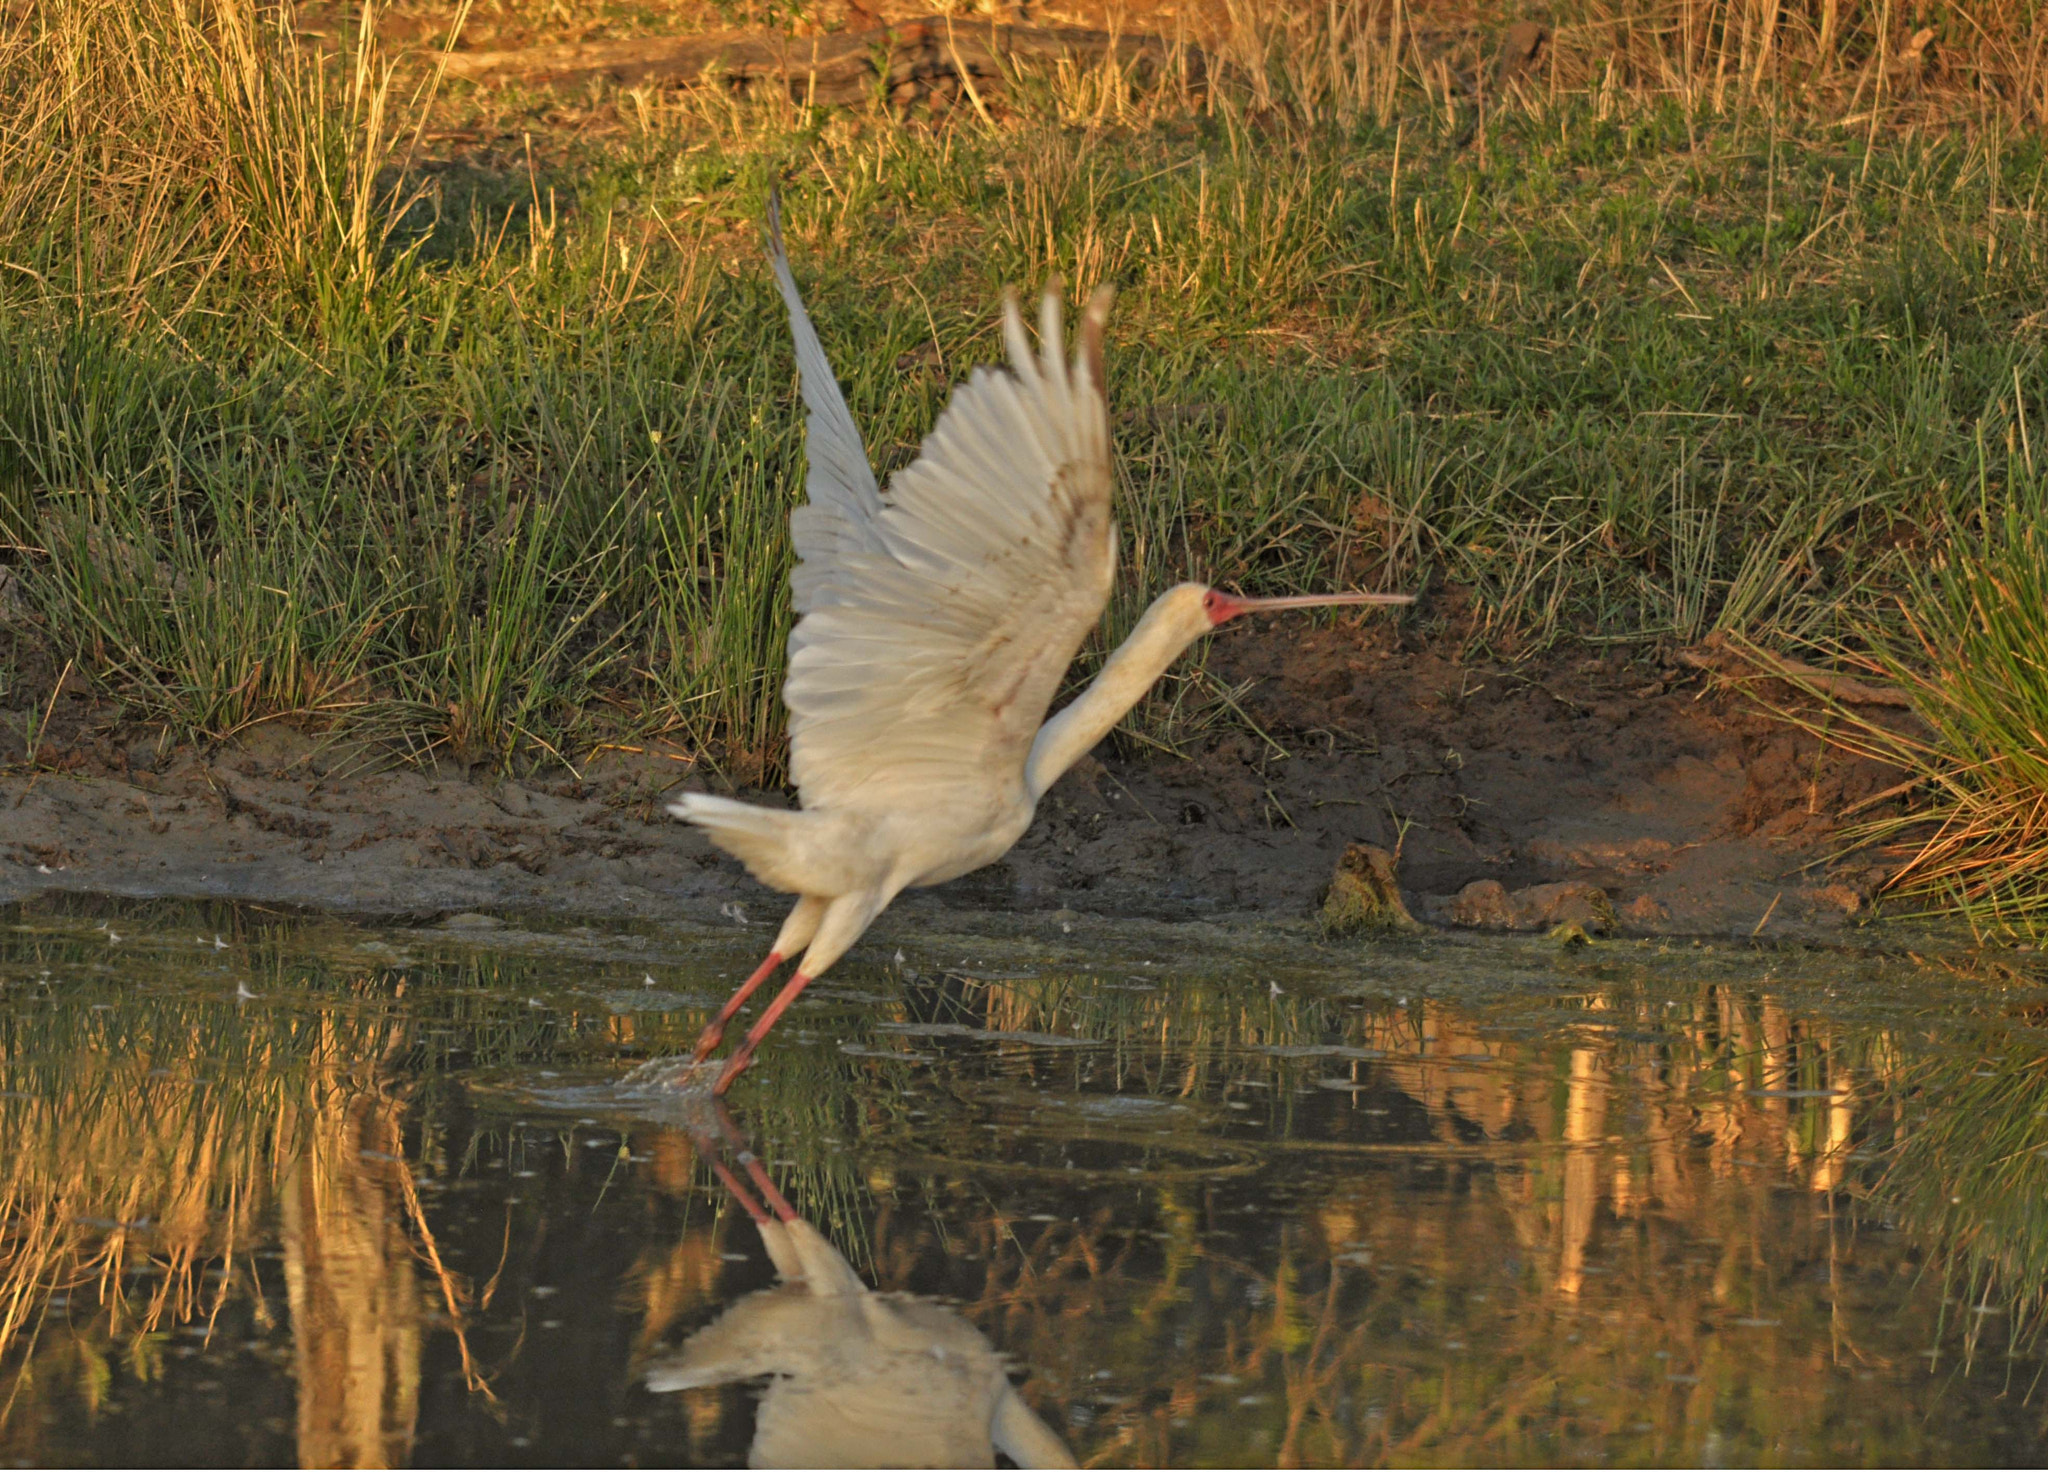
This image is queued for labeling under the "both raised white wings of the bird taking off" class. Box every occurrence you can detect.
[770,204,1116,809]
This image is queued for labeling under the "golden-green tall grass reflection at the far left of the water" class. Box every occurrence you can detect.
[0,903,559,1426]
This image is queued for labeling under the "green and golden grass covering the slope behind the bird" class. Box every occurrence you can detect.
[12,0,2048,860]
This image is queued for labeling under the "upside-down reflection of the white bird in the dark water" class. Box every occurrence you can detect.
[647,1106,1073,1469]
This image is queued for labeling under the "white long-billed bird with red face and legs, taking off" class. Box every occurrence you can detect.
[670,197,1409,1092]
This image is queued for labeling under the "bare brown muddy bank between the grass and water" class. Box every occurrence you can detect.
[0,623,1896,936]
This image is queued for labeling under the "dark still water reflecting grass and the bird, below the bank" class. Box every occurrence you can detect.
[0,899,2048,1465]
